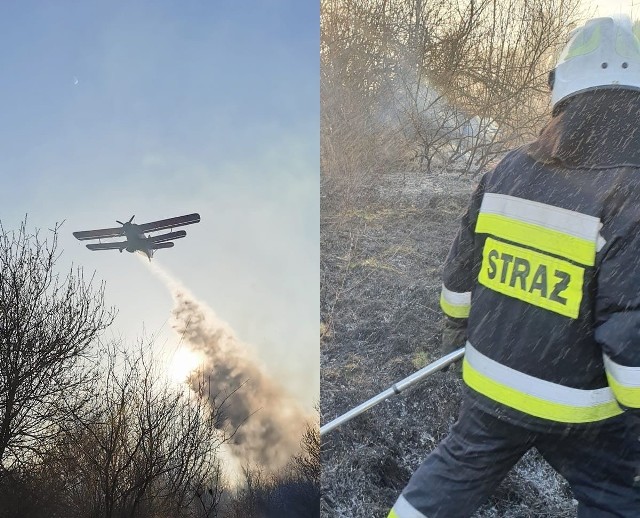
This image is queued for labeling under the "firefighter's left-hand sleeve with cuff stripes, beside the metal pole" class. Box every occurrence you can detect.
[440,177,484,360]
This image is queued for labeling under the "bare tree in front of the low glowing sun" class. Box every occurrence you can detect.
[52,347,226,518]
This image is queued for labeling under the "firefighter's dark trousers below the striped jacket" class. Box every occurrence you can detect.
[389,398,640,518]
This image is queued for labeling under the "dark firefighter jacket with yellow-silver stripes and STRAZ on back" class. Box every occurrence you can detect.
[440,90,640,430]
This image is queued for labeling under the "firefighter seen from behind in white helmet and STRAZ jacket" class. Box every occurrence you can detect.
[389,18,640,518]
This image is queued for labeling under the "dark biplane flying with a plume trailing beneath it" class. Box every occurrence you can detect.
[73,214,200,261]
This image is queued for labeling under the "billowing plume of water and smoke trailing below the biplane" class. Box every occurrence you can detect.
[147,263,307,472]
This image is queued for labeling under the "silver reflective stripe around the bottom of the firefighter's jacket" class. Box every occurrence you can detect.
[465,342,615,408]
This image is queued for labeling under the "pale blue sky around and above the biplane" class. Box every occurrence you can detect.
[0,0,319,410]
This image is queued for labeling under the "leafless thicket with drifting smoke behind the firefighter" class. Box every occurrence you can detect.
[321,0,581,207]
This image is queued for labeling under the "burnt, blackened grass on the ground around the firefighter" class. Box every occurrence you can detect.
[320,173,576,518]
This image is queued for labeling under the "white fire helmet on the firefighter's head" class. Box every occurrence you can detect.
[549,16,640,107]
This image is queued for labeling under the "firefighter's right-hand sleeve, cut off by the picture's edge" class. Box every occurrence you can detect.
[595,227,640,416]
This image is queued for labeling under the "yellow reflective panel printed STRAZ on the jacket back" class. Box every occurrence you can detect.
[478,237,584,318]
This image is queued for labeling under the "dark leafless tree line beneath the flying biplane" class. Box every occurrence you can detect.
[0,223,320,518]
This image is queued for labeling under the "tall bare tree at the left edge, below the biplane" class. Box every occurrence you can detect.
[0,220,112,470]
